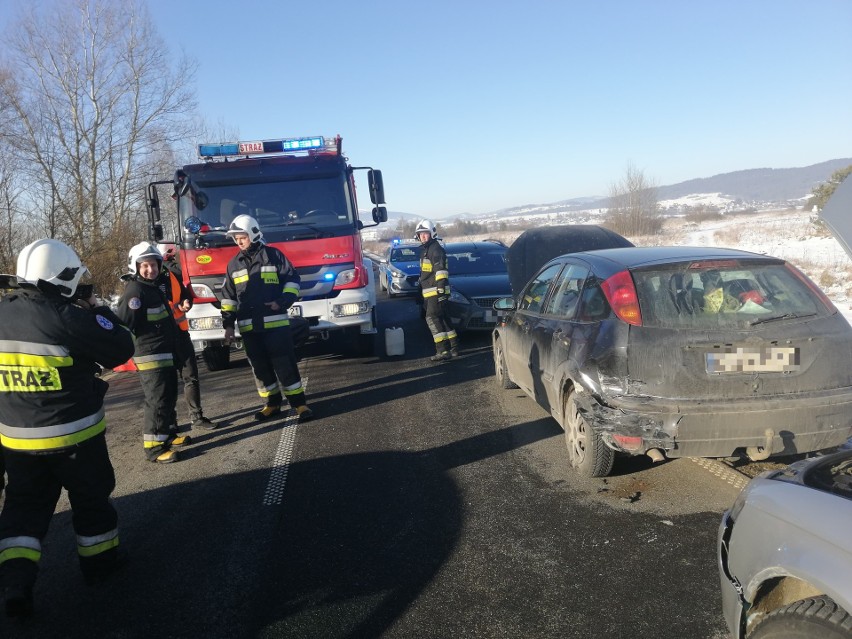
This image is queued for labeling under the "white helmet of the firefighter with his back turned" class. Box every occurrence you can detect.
[15,239,89,297]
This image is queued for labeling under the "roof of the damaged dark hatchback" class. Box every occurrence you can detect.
[551,246,784,269]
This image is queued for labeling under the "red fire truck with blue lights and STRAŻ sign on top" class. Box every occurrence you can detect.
[147,136,387,370]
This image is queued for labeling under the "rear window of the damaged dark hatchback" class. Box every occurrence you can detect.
[633,260,829,328]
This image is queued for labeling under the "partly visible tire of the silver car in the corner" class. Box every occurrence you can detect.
[748,597,852,639]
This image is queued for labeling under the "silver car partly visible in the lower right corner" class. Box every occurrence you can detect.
[717,448,852,639]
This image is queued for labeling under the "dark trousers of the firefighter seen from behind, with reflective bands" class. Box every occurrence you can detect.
[0,433,118,587]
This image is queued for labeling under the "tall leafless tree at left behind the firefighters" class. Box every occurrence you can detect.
[0,0,196,292]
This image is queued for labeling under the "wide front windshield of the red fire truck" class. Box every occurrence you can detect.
[179,177,354,235]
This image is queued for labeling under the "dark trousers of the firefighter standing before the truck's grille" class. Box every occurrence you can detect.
[242,326,306,408]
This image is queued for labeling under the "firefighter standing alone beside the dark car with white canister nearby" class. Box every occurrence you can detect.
[414,220,459,362]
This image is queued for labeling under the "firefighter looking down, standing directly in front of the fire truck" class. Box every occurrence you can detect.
[222,215,313,423]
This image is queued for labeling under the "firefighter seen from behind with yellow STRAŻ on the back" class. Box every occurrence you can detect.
[0,239,133,616]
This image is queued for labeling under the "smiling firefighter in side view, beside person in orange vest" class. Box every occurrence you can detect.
[116,242,190,464]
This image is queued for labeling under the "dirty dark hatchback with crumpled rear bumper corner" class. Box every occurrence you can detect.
[493,247,852,477]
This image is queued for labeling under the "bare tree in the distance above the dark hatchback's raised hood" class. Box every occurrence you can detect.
[605,163,663,237]
